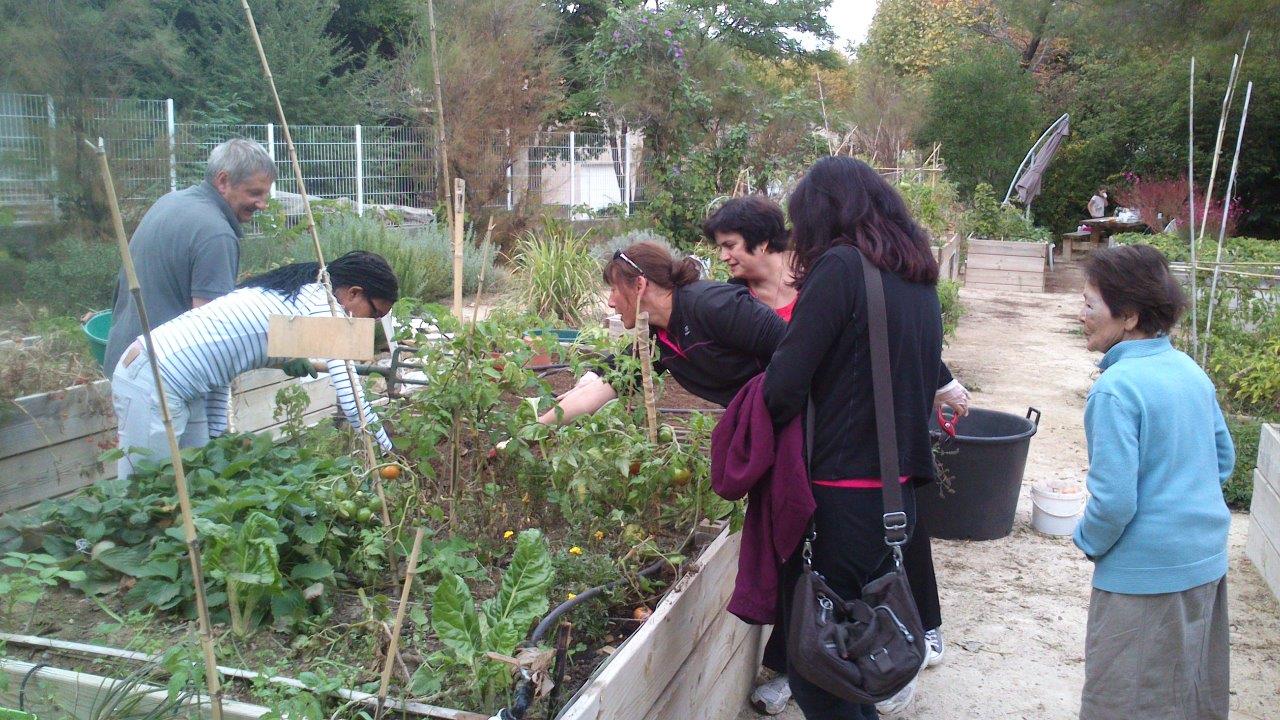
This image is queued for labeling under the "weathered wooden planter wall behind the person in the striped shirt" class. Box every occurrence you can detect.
[0,370,335,514]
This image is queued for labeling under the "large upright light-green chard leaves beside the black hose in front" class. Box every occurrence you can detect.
[431,529,554,702]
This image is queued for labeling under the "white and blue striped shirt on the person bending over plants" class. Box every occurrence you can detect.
[144,283,392,450]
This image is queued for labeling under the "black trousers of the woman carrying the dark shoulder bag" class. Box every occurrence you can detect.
[774,483,936,720]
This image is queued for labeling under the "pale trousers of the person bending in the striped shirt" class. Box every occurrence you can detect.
[111,350,209,479]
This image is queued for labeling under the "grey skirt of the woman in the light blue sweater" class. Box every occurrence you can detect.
[1080,577,1230,720]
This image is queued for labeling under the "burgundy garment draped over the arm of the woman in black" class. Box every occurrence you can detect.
[712,374,815,625]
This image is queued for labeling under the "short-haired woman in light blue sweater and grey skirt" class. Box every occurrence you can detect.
[1074,245,1235,720]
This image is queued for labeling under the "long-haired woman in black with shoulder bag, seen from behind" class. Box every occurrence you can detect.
[764,158,942,720]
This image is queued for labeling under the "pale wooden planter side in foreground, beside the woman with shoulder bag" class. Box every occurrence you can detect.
[557,528,765,720]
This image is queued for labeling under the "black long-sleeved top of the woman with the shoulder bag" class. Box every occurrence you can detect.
[764,246,950,480]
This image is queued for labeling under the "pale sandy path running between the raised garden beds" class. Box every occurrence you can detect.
[739,288,1280,720]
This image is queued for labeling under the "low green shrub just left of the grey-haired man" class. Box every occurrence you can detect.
[23,237,120,316]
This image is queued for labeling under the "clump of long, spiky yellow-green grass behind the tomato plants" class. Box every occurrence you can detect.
[513,219,600,327]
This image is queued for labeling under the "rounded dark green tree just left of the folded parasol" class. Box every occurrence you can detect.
[919,46,1047,193]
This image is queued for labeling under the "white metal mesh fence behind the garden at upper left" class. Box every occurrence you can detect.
[0,92,641,223]
